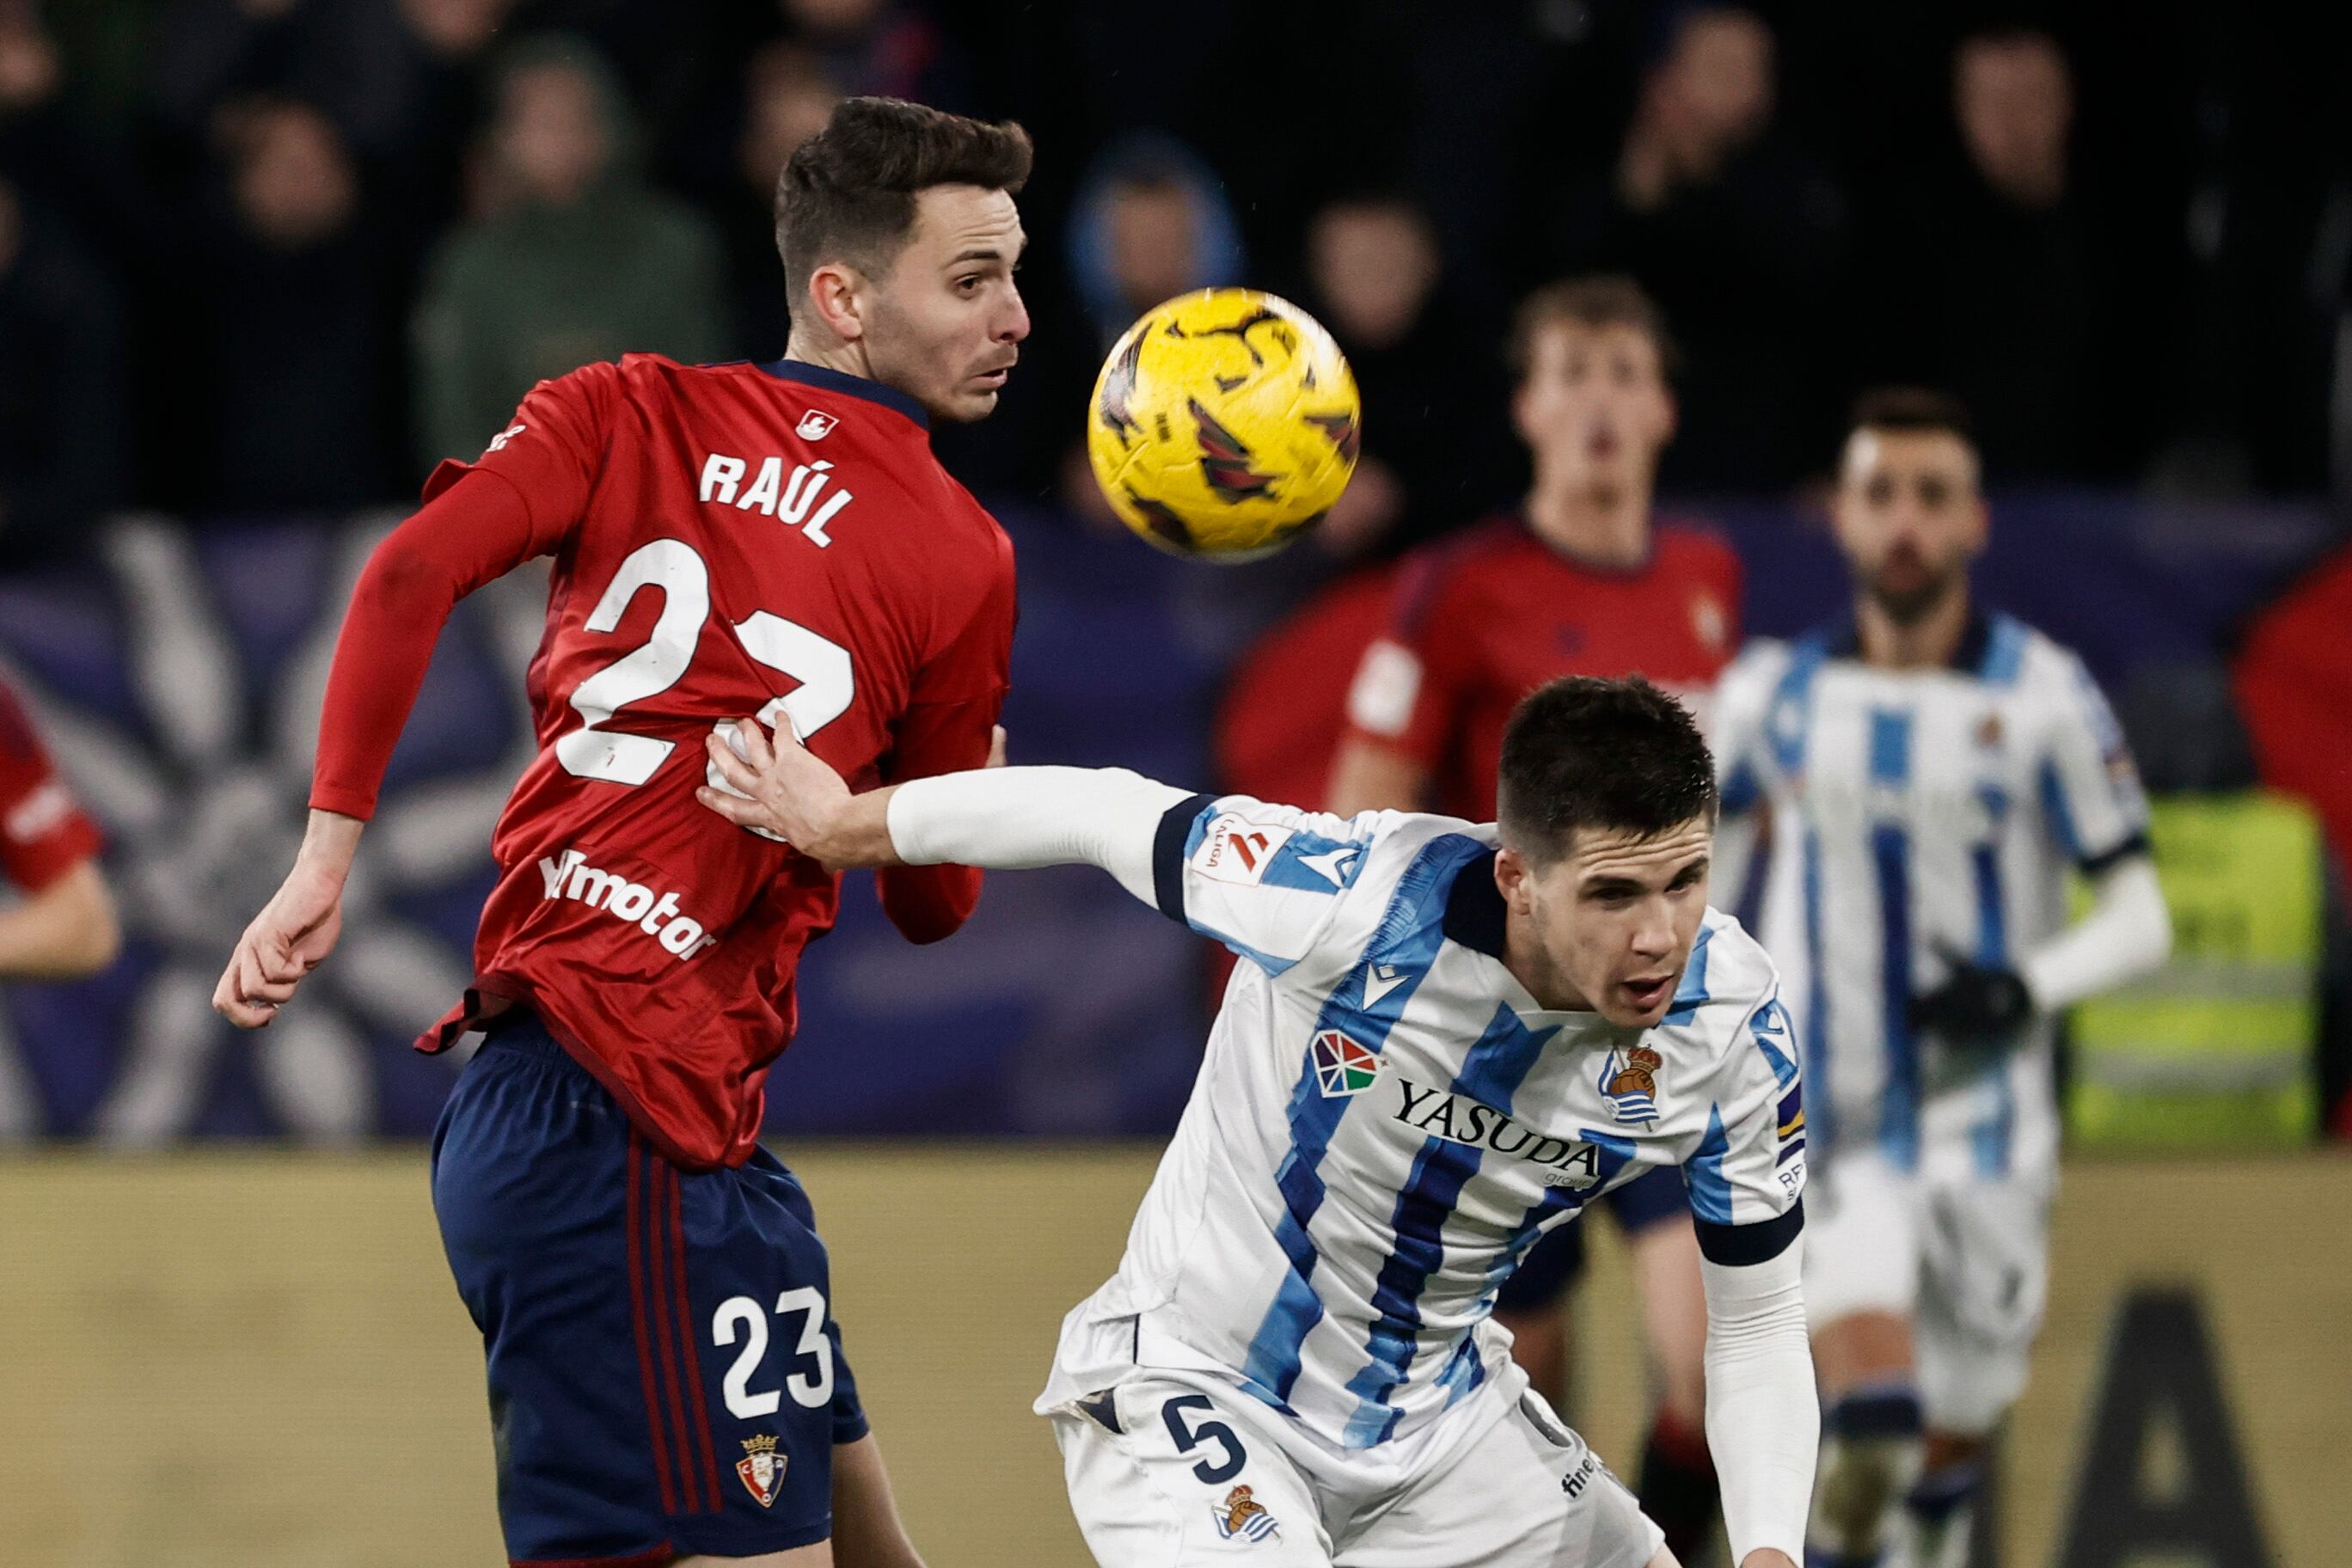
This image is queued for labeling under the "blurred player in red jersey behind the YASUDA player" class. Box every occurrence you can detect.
[1329,278,1741,1561]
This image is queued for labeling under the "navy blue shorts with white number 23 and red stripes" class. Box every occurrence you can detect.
[432,1014,866,1565]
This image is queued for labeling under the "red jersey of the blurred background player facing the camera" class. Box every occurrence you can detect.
[1348,515,1741,823]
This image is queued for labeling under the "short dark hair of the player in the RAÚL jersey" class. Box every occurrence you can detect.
[776,99,1030,320]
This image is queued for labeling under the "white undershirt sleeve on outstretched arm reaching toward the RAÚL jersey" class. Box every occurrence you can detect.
[889,769,1190,903]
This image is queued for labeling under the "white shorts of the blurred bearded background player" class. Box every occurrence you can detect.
[1804,1148,2055,1436]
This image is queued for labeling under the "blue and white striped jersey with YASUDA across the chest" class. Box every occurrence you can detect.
[1038,797,1804,1450]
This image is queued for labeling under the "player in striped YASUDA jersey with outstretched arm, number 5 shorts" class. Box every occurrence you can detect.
[701,677,1818,1568]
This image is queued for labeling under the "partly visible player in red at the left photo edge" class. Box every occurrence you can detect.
[0,684,122,1140]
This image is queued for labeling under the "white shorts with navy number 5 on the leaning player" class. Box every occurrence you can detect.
[1054,1369,1665,1568]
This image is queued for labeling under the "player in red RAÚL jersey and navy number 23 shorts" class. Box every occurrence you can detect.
[217,99,1030,1568]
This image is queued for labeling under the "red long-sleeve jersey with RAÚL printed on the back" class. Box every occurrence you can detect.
[313,355,1014,1168]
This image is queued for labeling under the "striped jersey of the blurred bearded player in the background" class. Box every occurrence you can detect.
[1715,616,2147,1175]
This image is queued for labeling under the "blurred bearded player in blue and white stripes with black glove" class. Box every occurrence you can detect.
[1717,390,2171,1568]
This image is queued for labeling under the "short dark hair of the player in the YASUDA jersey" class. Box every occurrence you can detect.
[1496,675,1715,865]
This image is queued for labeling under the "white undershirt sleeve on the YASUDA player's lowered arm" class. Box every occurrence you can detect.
[1698,1234,1821,1564]
